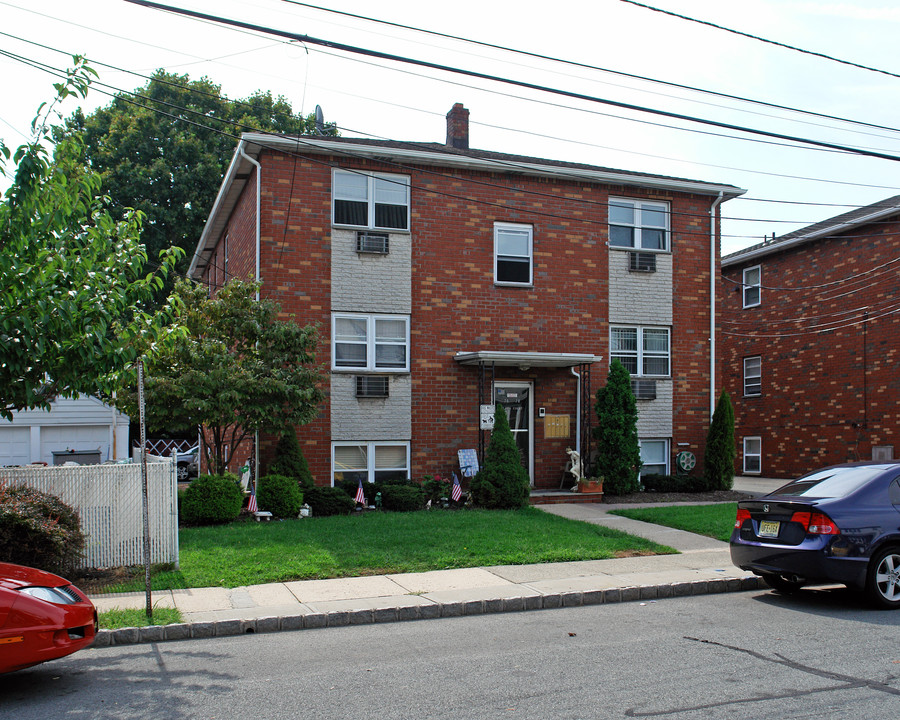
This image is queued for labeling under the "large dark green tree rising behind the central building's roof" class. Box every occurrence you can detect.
[69,70,337,270]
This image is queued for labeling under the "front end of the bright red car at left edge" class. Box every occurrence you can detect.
[0,562,97,673]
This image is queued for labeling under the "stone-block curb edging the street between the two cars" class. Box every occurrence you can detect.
[93,577,768,647]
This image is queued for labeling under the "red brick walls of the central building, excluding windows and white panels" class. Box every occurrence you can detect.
[192,115,740,488]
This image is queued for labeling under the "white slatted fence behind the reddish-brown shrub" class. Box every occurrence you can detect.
[0,458,178,568]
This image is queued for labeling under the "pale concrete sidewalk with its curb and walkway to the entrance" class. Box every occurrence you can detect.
[91,478,783,646]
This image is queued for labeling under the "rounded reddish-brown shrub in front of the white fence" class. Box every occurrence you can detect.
[0,483,84,575]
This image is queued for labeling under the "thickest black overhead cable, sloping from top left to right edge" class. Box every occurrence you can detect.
[126,0,900,162]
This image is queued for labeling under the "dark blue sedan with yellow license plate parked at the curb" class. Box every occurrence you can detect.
[731,462,900,608]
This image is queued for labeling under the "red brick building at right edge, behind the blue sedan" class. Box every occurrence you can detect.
[719,196,900,478]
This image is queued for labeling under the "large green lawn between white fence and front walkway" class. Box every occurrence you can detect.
[107,508,675,592]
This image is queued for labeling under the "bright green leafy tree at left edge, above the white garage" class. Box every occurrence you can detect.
[0,62,177,419]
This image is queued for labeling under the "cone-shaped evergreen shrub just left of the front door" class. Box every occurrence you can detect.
[470,403,531,510]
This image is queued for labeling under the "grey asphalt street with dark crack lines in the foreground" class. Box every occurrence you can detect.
[0,590,900,720]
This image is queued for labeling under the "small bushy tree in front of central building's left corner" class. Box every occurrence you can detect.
[117,280,324,474]
